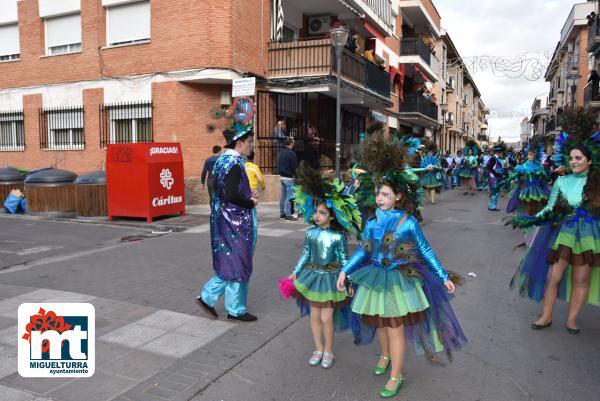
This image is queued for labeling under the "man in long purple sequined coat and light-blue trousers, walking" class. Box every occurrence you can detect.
[196,98,258,322]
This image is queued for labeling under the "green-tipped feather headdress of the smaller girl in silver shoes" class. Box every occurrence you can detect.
[294,161,361,234]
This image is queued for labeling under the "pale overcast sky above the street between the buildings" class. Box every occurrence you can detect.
[433,0,585,141]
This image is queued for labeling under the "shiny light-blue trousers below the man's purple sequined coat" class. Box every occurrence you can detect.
[199,276,248,316]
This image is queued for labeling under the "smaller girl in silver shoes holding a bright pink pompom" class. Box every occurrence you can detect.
[289,162,361,368]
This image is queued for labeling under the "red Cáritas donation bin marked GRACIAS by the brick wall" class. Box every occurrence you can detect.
[106,143,185,223]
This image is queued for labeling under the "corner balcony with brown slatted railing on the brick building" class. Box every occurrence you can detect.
[267,39,390,99]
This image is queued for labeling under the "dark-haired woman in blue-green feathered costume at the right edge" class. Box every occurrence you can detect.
[511,132,600,334]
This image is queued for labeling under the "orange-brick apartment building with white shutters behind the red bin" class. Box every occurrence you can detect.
[0,0,401,202]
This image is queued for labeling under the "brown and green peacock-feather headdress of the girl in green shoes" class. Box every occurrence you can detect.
[356,135,419,209]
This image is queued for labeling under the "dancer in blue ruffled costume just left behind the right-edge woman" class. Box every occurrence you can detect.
[492,137,550,215]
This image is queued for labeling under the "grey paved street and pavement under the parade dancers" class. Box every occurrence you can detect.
[0,190,600,401]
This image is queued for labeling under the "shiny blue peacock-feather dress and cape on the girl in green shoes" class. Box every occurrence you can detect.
[342,209,467,358]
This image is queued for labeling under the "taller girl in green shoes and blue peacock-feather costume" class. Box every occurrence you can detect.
[337,134,467,398]
